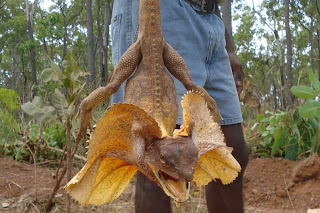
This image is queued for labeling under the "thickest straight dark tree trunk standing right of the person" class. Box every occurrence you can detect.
[284,0,294,108]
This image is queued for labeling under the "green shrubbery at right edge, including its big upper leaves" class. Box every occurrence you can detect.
[251,71,320,160]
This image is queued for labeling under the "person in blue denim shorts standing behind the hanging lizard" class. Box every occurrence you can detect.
[111,0,248,213]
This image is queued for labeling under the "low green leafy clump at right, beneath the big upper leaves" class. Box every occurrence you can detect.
[249,108,320,160]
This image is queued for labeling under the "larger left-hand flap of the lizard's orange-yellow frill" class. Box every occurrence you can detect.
[66,104,161,205]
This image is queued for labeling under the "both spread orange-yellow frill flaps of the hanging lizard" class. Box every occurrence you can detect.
[66,92,241,205]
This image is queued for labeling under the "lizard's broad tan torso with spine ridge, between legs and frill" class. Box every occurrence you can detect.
[124,61,179,136]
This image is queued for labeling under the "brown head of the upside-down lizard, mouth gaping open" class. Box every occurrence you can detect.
[145,136,198,202]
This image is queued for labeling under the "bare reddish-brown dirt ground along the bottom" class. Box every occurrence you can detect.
[0,155,320,213]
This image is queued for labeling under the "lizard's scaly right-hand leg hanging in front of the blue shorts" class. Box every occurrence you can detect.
[163,43,223,121]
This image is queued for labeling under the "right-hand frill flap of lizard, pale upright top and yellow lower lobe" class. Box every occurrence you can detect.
[177,92,241,187]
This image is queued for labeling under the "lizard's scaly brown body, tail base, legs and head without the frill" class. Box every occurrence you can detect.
[76,0,220,202]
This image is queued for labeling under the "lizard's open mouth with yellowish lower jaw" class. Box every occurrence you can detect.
[149,164,190,203]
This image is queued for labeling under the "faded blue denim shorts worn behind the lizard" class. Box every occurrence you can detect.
[111,0,242,125]
